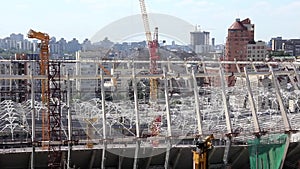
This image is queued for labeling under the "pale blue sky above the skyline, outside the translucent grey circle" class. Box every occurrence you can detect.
[0,0,300,44]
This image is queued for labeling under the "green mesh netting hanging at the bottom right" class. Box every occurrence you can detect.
[248,134,288,169]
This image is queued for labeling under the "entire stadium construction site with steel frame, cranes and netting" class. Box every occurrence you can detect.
[0,0,300,169]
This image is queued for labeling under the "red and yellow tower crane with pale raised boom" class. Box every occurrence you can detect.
[139,0,159,102]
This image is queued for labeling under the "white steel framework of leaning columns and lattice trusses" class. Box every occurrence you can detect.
[0,60,300,167]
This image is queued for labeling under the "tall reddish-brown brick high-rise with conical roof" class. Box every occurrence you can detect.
[224,18,254,73]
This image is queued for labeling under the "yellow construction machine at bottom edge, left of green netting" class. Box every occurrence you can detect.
[193,134,214,169]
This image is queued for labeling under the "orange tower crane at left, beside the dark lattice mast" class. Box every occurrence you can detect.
[27,29,50,148]
